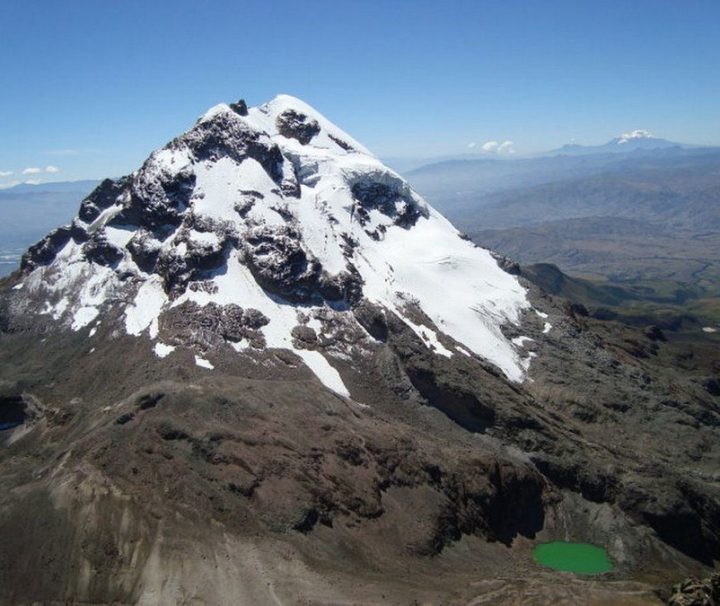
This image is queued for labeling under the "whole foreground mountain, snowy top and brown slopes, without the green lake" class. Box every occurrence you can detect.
[0,96,720,604]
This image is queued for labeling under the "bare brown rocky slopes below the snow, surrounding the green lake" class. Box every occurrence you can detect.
[0,274,720,605]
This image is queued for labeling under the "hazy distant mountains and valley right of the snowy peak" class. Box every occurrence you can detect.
[400,144,720,322]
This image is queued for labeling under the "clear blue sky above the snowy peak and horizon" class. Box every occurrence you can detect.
[0,0,720,186]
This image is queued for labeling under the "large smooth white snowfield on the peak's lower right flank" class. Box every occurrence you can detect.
[355,211,529,381]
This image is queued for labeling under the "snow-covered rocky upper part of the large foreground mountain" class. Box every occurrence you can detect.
[8,95,531,395]
